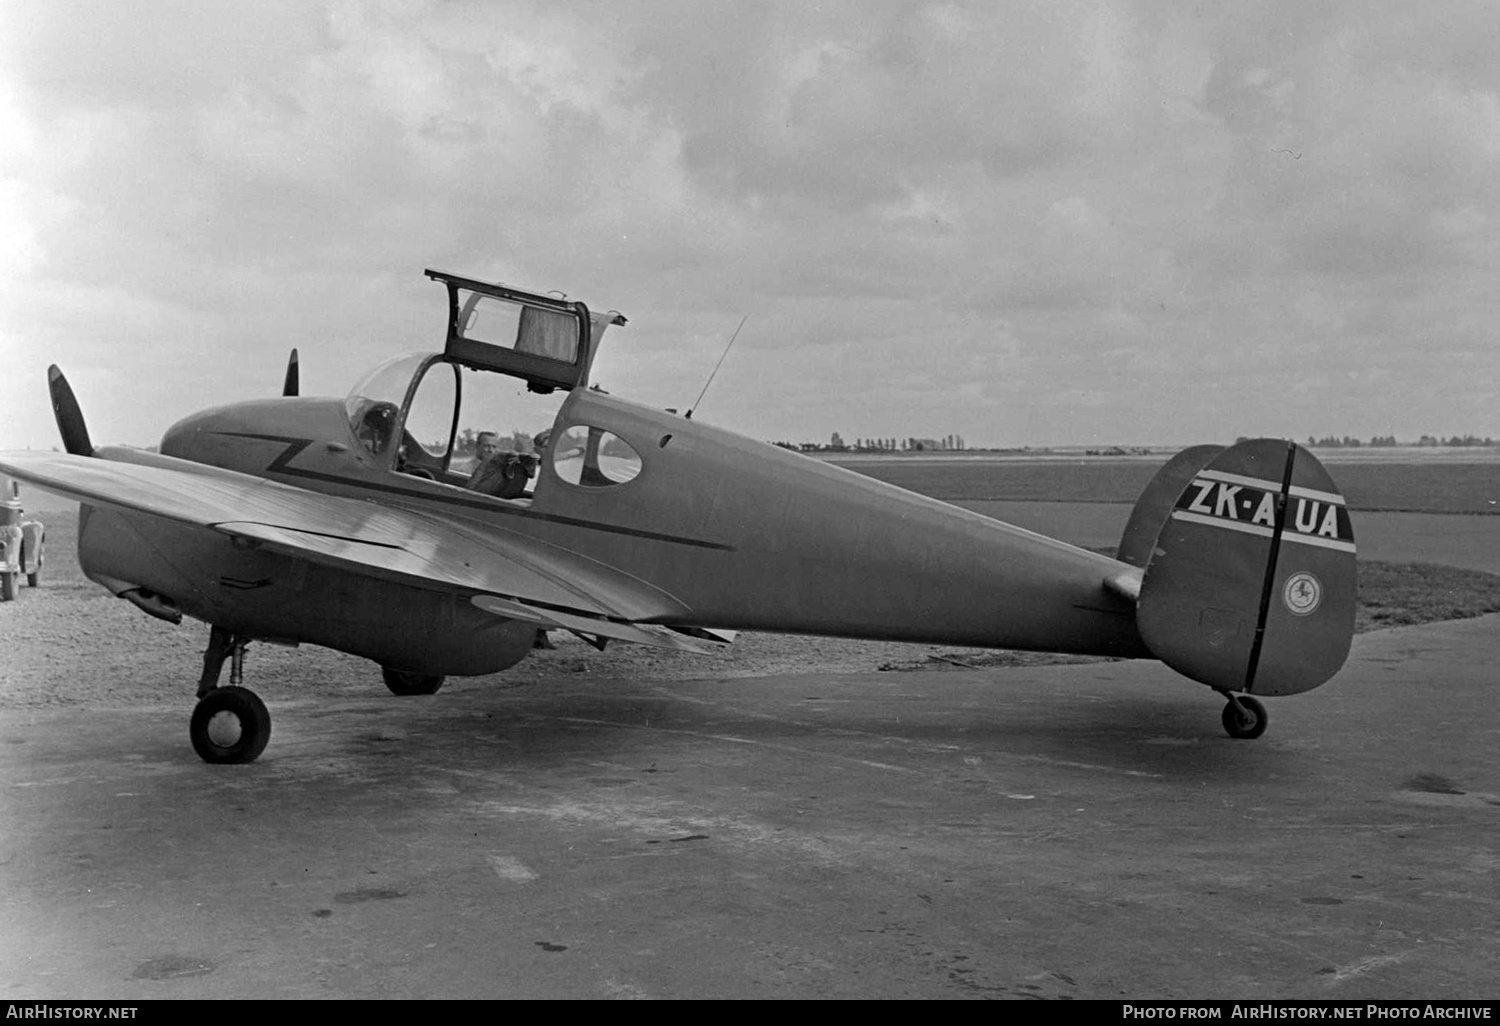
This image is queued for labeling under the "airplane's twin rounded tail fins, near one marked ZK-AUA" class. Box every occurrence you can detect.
[1121,438,1356,695]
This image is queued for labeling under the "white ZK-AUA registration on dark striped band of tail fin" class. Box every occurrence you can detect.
[1172,471,1355,552]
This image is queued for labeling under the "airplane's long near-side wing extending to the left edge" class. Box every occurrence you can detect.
[0,449,705,648]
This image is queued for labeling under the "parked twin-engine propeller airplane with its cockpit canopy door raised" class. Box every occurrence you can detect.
[0,270,1356,764]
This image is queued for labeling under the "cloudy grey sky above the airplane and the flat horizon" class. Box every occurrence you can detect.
[0,0,1500,449]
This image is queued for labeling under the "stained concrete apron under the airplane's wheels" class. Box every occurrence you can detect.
[0,617,1500,999]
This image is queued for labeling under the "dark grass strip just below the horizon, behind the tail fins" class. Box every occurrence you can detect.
[839,458,1500,516]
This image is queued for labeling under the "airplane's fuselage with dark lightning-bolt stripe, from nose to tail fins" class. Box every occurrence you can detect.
[149,381,1148,656]
